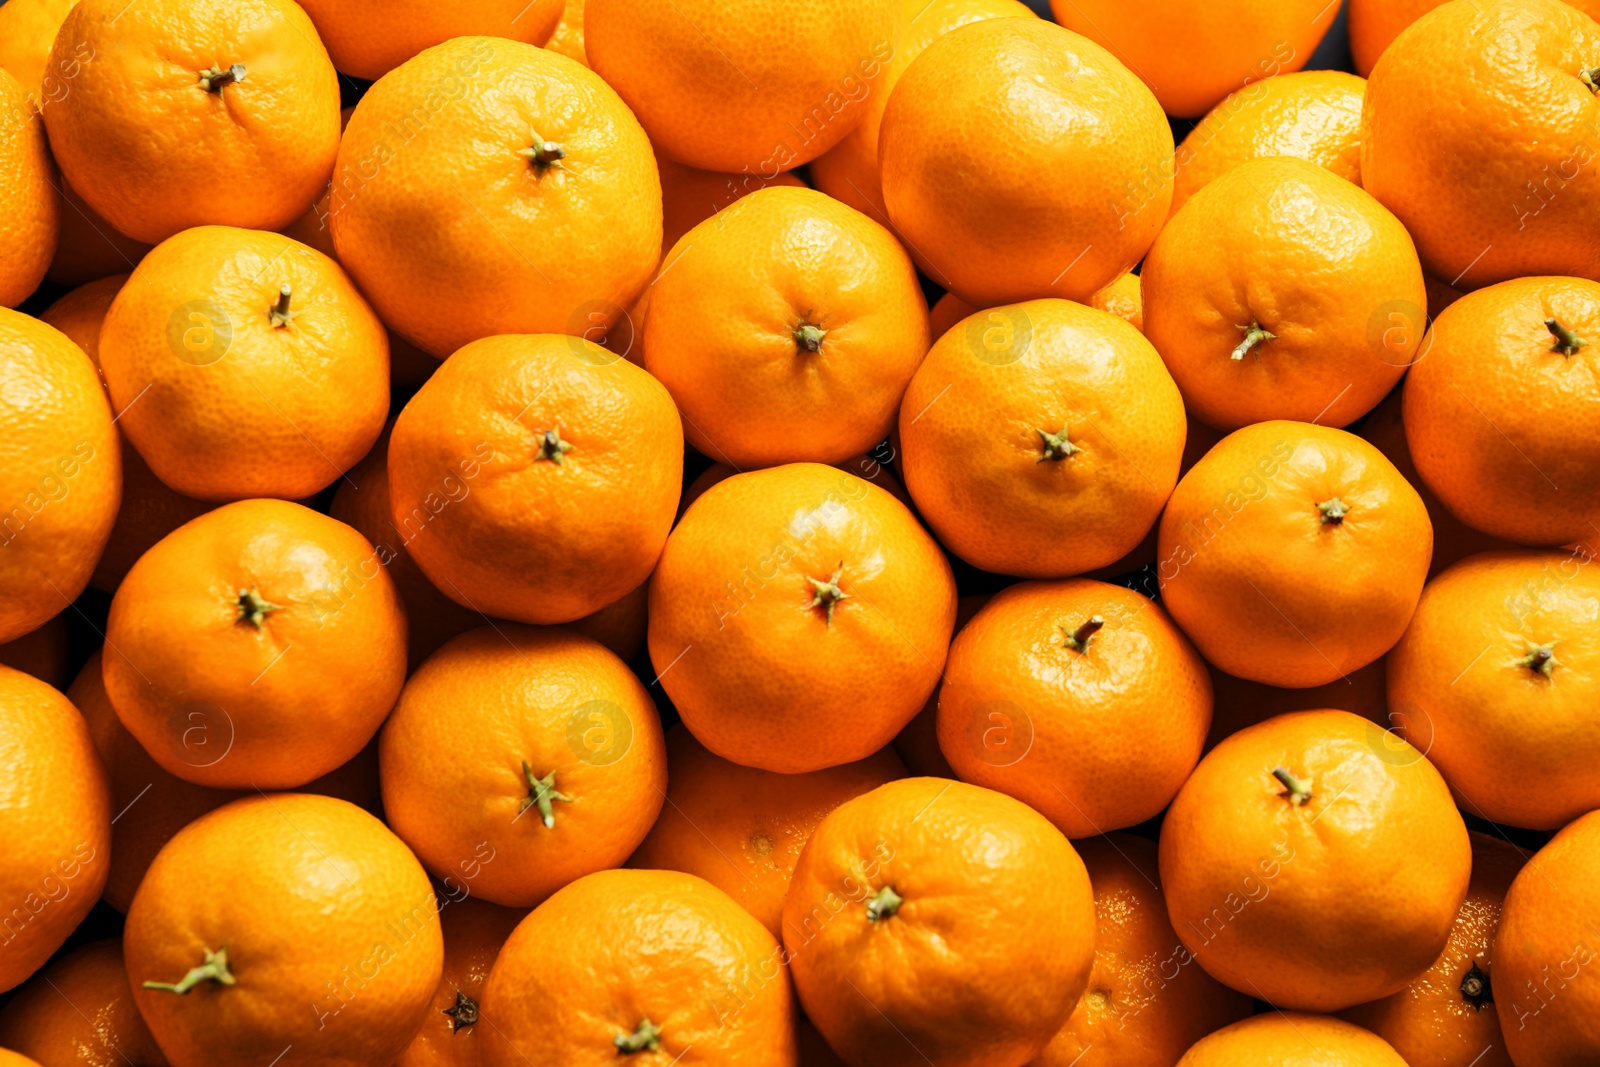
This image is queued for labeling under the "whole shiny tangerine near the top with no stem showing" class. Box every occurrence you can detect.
[878,18,1173,307]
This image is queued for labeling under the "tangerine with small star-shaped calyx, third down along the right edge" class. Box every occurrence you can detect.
[1389,550,1600,830]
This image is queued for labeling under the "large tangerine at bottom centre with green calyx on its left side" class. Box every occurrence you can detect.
[784,777,1094,1067]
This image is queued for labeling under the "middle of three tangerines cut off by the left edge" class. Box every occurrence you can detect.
[0,307,122,641]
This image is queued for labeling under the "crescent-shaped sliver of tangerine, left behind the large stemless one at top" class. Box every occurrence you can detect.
[812,0,1034,231]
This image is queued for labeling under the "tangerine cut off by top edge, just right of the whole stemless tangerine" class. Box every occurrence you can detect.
[1050,0,1339,118]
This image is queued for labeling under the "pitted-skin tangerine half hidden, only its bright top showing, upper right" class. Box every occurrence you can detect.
[1173,70,1366,213]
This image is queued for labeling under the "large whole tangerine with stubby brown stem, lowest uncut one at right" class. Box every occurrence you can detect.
[1162,710,1472,1011]
